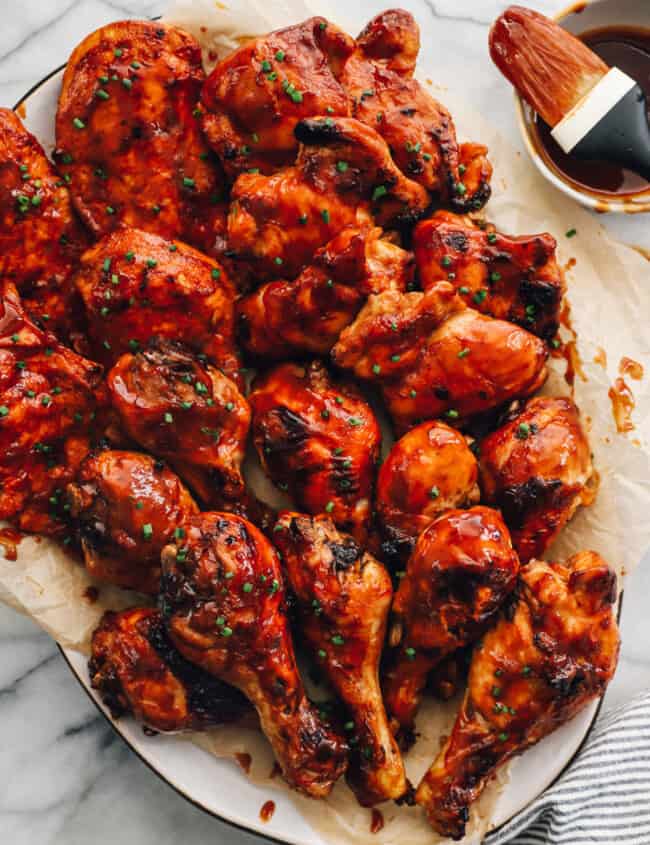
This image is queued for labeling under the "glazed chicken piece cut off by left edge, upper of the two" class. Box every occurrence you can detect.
[0,109,88,342]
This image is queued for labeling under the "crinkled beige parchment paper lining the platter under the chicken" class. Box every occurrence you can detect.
[0,0,650,845]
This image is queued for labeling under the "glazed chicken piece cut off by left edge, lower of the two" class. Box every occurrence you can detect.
[0,281,102,542]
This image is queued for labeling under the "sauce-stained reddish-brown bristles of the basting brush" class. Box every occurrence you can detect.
[490,6,609,126]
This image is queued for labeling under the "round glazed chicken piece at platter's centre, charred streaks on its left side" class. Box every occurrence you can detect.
[248,361,381,541]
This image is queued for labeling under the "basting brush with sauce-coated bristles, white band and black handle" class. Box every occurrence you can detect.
[490,6,650,181]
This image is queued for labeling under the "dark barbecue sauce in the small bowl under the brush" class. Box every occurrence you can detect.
[536,26,650,196]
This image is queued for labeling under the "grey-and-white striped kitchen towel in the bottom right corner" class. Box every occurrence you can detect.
[484,692,650,845]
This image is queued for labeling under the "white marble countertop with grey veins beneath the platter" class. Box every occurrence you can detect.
[0,0,650,845]
